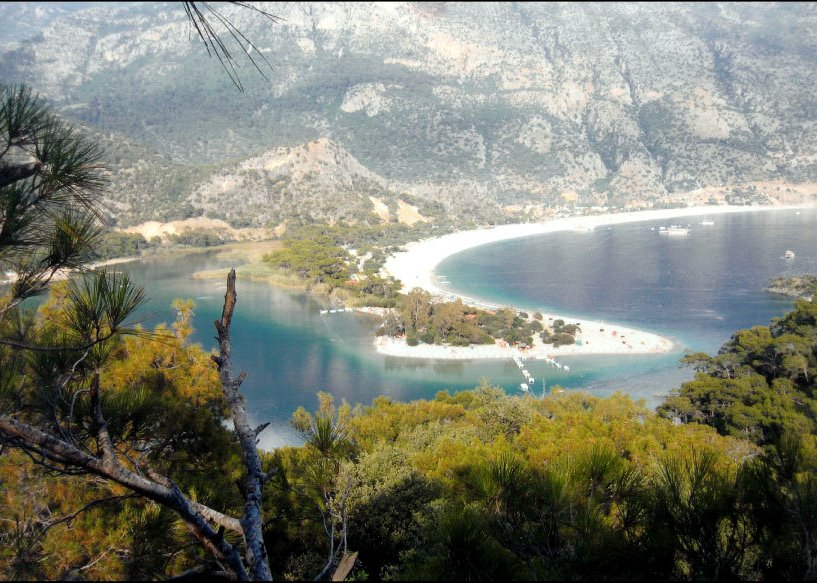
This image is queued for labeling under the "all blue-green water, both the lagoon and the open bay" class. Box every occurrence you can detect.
[123,209,817,447]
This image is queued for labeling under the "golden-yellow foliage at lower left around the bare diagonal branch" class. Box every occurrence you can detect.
[0,298,241,579]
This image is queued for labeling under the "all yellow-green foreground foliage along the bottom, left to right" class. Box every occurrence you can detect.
[0,292,817,580]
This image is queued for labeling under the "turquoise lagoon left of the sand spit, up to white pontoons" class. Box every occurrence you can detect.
[121,251,568,447]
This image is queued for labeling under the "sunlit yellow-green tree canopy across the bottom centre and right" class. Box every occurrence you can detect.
[258,384,815,580]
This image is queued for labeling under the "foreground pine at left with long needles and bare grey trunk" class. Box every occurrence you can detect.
[0,86,271,580]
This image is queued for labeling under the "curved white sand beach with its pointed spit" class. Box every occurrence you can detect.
[374,205,813,360]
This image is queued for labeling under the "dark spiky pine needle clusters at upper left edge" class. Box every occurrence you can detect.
[0,84,105,308]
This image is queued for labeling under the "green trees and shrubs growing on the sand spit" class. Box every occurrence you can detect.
[263,224,578,347]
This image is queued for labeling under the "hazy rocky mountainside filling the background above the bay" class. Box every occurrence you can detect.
[0,2,817,225]
